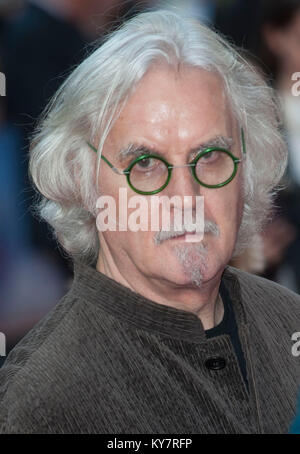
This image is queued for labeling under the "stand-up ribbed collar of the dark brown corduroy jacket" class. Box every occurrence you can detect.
[70,261,246,343]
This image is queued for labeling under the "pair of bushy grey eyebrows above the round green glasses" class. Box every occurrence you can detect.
[117,135,234,162]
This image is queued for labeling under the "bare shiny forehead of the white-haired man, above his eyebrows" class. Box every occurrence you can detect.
[102,65,235,156]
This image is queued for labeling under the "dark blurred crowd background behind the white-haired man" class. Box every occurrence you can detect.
[0,0,300,366]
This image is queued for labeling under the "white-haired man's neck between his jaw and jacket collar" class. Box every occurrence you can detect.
[96,242,224,330]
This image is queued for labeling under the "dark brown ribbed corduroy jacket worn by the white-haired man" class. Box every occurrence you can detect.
[0,263,300,434]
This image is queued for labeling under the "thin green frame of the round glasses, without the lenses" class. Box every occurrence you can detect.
[86,128,246,195]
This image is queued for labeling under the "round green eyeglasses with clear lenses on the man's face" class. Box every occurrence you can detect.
[87,130,246,195]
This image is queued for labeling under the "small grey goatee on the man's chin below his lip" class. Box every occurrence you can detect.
[174,243,207,287]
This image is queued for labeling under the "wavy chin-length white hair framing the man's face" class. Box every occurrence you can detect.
[29,10,287,263]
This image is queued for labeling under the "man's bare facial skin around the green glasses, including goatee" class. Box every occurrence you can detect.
[99,66,243,286]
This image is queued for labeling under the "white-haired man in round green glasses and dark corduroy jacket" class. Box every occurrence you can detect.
[0,11,300,434]
